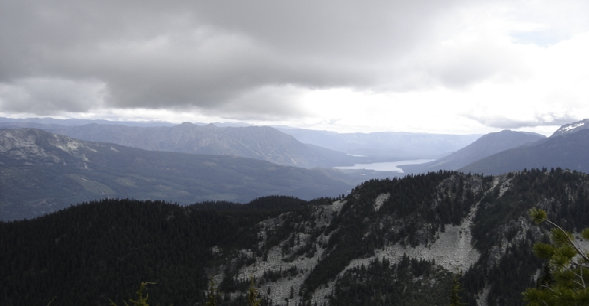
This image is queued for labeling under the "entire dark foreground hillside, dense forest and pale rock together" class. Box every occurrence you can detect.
[0,169,589,305]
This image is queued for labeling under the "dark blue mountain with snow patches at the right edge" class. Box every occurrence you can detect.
[462,121,589,174]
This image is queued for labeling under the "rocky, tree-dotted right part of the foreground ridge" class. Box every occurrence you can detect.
[203,170,589,305]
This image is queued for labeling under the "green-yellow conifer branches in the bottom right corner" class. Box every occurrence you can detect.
[523,208,589,306]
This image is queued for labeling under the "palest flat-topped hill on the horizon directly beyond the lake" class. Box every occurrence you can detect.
[280,127,480,161]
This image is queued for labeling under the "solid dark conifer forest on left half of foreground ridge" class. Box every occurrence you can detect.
[0,197,298,305]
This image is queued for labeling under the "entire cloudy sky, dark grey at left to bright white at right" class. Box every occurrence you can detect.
[0,0,589,135]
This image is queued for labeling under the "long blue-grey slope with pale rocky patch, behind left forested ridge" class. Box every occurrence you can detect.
[0,129,358,220]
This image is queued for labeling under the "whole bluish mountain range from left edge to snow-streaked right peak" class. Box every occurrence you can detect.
[0,118,589,182]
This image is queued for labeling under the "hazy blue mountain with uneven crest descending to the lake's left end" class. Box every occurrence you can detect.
[52,123,360,168]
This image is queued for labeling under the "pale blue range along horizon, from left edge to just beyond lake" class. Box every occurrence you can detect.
[0,118,480,168]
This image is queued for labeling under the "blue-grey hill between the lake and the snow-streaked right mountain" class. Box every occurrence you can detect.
[402,130,546,173]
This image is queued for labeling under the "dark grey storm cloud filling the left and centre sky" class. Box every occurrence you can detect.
[0,0,468,116]
